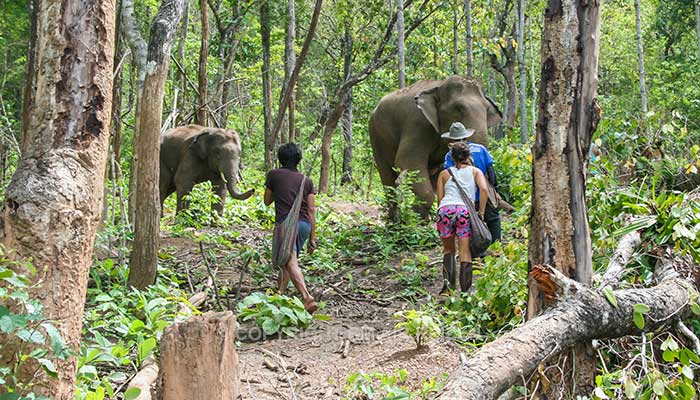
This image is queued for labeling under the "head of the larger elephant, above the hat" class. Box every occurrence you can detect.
[414,76,502,146]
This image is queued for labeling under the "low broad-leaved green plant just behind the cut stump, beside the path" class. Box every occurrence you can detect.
[237,292,324,337]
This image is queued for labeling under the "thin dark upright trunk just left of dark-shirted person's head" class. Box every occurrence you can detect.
[260,1,275,170]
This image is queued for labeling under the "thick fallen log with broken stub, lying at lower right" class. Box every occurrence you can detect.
[437,265,697,400]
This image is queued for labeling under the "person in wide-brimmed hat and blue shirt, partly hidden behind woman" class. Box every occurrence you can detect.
[441,122,501,250]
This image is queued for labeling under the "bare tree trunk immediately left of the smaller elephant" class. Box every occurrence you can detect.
[128,0,183,289]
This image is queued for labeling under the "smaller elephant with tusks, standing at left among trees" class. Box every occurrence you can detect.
[160,125,255,214]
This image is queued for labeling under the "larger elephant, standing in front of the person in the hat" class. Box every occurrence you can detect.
[369,76,502,218]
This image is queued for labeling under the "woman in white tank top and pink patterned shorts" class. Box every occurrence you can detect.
[437,142,488,292]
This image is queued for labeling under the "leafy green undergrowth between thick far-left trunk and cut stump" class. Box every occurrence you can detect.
[76,259,187,400]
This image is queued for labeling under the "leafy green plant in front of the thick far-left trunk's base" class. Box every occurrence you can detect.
[0,247,72,400]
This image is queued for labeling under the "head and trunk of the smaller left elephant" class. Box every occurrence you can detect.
[189,129,255,200]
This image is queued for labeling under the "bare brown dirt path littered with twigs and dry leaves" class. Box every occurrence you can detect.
[161,202,461,400]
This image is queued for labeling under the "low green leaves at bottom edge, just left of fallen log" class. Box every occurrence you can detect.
[343,369,447,400]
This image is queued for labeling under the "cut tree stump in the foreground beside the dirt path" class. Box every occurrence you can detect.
[160,311,240,400]
